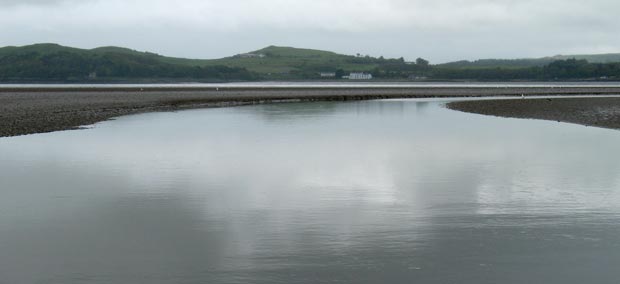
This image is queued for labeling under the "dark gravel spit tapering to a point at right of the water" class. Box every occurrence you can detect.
[448,97,620,129]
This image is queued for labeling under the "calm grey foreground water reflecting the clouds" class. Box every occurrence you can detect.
[0,100,620,284]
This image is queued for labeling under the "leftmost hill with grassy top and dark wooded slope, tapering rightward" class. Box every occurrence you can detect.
[0,43,258,82]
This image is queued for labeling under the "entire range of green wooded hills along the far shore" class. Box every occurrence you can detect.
[0,43,620,83]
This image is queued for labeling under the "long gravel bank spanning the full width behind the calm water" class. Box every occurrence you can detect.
[0,87,620,137]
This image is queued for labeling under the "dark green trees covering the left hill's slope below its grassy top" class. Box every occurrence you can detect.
[0,51,258,81]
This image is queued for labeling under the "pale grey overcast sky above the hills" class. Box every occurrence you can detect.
[0,0,620,63]
